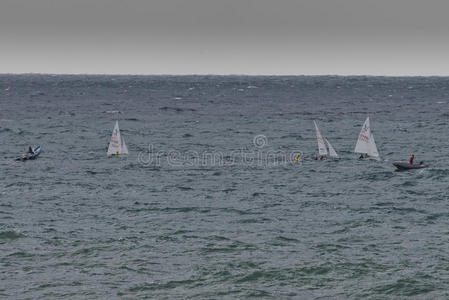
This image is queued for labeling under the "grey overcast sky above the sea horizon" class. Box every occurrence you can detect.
[0,0,449,75]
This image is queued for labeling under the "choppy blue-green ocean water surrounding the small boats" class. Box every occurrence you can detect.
[0,75,449,299]
